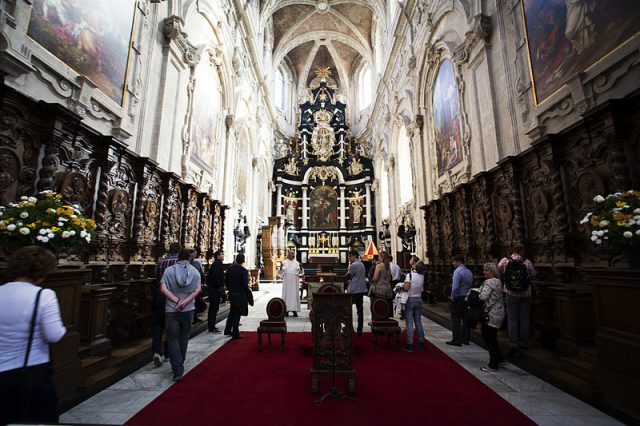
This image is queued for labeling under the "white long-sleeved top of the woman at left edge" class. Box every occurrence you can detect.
[0,282,67,371]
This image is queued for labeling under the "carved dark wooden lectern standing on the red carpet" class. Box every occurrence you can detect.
[311,293,356,394]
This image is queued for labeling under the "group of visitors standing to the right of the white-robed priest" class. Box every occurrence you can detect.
[346,243,535,371]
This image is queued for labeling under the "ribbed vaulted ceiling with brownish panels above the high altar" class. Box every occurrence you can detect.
[261,0,385,90]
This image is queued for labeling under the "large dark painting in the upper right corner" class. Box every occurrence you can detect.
[524,0,640,103]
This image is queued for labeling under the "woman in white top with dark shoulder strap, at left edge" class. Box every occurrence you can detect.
[0,246,67,425]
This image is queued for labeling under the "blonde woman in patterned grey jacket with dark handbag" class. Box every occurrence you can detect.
[471,263,504,372]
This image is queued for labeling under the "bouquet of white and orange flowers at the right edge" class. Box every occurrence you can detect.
[580,190,640,250]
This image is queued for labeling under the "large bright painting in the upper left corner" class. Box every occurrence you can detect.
[27,0,136,104]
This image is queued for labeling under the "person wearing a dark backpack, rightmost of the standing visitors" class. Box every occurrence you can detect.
[498,243,536,357]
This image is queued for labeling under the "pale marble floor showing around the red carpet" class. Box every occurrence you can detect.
[60,283,621,425]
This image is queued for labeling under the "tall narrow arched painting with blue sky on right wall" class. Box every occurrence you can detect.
[433,59,462,175]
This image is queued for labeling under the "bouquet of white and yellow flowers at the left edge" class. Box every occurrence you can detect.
[0,191,96,253]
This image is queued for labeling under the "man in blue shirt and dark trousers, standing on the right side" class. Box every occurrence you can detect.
[446,254,473,346]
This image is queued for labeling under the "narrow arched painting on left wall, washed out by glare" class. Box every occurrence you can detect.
[191,61,220,173]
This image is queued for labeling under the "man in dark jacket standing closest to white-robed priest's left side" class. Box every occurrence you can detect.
[224,253,253,339]
